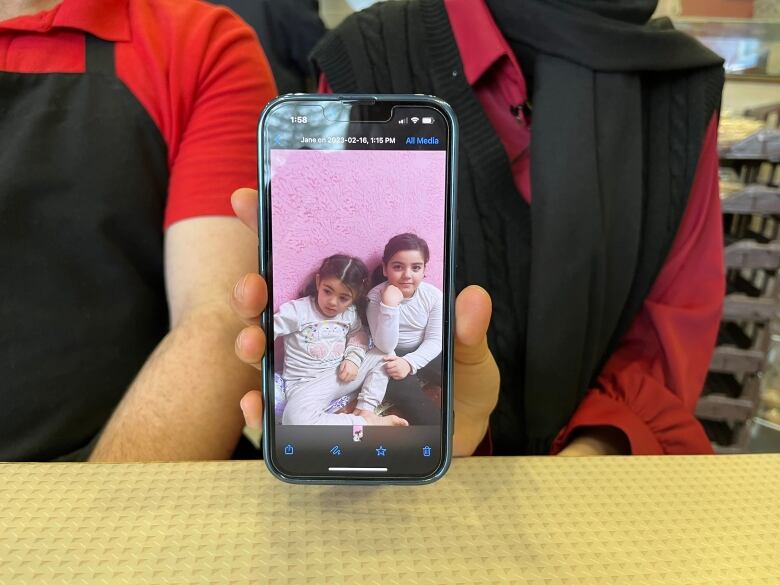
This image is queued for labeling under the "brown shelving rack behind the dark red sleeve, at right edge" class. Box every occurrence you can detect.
[696,104,780,453]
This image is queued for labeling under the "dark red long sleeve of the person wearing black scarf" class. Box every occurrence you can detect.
[552,117,725,455]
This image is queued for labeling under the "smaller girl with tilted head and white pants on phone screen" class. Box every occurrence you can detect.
[274,254,407,426]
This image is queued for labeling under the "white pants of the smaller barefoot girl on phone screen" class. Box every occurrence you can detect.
[282,348,388,425]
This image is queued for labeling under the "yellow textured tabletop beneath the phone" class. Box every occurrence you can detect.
[0,455,780,585]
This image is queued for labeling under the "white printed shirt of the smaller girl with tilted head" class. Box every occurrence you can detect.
[274,297,366,381]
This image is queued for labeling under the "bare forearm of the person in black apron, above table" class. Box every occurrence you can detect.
[90,303,260,461]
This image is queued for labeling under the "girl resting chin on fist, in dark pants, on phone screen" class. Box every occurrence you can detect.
[366,233,444,424]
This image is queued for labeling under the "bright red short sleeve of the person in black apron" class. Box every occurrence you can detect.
[164,7,276,229]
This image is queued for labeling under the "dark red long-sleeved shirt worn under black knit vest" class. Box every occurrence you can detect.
[445,0,725,455]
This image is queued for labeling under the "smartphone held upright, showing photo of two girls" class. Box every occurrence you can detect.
[258,94,458,484]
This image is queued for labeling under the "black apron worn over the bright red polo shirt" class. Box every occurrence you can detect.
[0,36,168,461]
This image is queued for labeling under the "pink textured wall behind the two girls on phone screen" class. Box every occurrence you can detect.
[271,150,446,310]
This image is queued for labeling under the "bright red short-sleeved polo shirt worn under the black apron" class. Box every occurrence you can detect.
[0,0,276,228]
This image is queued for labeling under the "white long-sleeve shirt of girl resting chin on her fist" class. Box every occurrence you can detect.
[366,282,444,373]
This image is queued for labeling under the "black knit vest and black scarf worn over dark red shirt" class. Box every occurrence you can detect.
[313,0,723,454]
